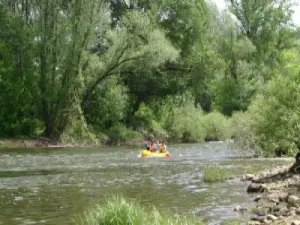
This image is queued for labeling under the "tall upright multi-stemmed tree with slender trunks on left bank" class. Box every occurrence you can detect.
[34,0,107,138]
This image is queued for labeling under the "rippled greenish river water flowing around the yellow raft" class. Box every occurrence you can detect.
[0,142,291,225]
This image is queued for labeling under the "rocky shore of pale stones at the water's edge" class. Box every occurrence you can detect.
[242,163,300,225]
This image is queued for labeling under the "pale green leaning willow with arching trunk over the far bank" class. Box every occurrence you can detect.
[81,10,178,128]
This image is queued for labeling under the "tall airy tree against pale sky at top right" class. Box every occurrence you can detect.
[228,0,293,66]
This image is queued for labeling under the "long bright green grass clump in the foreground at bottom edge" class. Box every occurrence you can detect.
[76,197,203,225]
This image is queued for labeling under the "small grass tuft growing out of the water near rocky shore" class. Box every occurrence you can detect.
[203,165,228,183]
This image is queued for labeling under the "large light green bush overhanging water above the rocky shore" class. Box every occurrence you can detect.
[249,76,300,156]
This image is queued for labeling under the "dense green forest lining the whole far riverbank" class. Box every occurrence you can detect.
[0,0,300,155]
